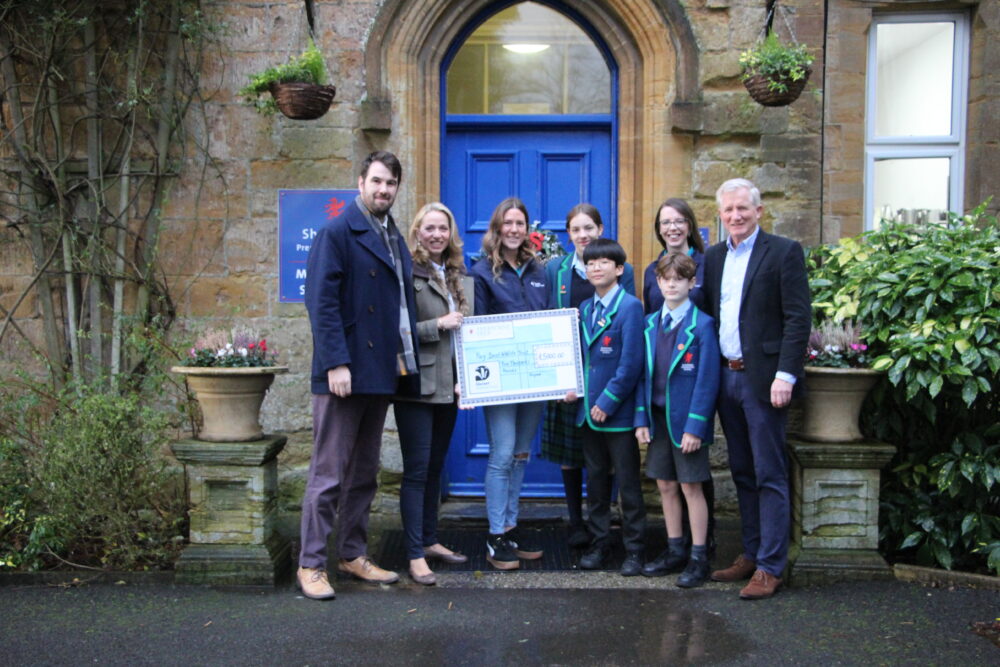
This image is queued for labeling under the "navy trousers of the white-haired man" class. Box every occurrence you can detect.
[718,368,791,577]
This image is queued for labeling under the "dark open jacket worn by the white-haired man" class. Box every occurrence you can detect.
[702,229,812,403]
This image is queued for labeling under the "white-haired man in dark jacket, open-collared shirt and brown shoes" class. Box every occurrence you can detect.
[704,178,811,600]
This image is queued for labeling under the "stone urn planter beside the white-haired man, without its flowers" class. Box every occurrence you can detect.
[800,366,883,442]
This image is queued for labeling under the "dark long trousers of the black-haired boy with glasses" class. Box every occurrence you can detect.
[582,426,646,551]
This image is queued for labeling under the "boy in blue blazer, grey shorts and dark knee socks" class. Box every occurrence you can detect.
[635,253,721,588]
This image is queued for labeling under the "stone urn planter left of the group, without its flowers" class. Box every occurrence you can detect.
[170,366,288,442]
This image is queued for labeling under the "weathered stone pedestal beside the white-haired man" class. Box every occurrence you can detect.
[788,440,896,585]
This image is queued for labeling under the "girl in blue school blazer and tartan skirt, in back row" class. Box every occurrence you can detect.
[542,204,635,547]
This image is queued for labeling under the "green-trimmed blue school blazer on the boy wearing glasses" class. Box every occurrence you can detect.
[576,289,643,431]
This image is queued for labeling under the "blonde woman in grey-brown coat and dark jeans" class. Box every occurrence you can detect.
[393,203,475,586]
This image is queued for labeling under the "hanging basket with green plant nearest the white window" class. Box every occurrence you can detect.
[740,32,813,107]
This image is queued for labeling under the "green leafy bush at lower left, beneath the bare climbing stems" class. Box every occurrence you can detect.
[0,381,185,569]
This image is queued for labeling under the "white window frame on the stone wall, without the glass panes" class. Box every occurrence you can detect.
[864,12,969,231]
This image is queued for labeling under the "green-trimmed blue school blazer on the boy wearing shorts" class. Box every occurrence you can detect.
[641,304,722,447]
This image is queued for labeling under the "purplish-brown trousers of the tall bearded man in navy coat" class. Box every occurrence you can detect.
[299,394,389,568]
